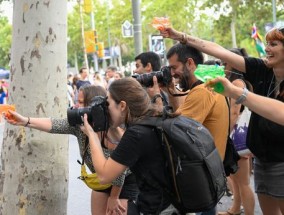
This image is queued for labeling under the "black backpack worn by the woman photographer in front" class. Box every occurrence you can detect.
[136,116,226,213]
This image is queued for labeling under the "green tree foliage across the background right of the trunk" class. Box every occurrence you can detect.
[65,0,284,65]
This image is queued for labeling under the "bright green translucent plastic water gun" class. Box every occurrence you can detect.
[194,64,225,94]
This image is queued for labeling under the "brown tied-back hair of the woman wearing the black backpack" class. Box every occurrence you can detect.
[108,78,158,125]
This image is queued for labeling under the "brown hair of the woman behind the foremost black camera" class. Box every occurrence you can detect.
[79,84,107,107]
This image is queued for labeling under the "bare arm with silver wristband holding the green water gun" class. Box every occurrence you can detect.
[206,77,284,125]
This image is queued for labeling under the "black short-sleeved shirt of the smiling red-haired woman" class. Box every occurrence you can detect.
[244,57,284,162]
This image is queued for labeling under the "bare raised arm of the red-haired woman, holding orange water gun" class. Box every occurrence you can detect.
[160,27,245,72]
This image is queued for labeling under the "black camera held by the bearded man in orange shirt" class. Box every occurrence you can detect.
[132,66,172,87]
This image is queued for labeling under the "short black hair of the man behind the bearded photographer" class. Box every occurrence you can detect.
[135,52,161,71]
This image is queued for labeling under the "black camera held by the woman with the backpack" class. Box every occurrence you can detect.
[67,96,109,131]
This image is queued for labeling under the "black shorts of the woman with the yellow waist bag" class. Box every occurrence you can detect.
[95,174,139,201]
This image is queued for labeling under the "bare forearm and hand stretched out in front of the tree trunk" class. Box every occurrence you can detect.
[4,110,52,132]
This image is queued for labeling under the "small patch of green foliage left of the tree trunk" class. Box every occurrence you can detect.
[0,15,12,68]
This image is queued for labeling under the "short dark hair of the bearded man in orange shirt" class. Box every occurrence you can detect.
[167,43,204,65]
